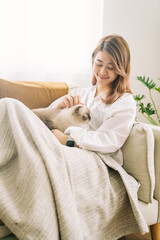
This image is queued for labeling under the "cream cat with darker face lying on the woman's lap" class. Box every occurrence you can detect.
[32,104,91,132]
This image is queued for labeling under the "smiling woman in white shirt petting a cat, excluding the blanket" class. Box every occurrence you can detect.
[52,35,136,156]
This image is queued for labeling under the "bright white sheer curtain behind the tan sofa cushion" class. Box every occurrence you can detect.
[0,0,103,86]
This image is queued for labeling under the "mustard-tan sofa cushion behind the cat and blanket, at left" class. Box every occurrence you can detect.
[0,79,68,109]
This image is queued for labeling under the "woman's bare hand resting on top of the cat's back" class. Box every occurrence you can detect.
[57,94,80,108]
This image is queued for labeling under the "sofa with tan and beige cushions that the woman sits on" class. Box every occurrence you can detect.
[0,79,160,240]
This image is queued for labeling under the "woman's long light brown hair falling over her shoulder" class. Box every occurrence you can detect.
[92,35,132,104]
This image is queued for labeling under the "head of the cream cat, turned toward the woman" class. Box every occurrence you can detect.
[70,104,91,124]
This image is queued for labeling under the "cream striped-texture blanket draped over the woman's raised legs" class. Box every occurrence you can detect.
[0,98,148,240]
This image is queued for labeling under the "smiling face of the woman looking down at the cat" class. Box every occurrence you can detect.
[92,51,117,88]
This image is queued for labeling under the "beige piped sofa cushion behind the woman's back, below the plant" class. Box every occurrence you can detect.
[122,123,155,203]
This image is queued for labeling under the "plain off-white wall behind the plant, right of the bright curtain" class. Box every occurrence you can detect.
[103,0,160,124]
